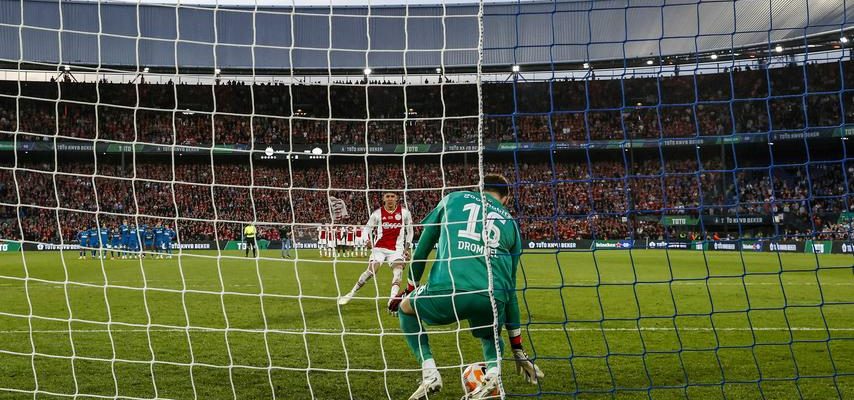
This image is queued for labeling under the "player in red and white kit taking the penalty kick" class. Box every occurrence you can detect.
[338,192,413,306]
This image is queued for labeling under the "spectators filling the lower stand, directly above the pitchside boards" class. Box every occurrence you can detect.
[0,159,854,242]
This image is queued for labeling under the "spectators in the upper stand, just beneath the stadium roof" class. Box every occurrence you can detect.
[0,62,854,148]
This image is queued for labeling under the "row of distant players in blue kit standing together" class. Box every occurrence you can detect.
[77,220,178,260]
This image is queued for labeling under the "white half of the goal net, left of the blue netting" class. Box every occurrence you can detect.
[0,1,508,399]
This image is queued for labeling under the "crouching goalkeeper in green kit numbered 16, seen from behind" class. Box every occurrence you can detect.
[389,175,543,400]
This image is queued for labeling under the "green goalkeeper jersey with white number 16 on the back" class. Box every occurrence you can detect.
[411,191,522,306]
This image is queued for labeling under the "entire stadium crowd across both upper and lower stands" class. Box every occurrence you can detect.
[0,62,854,242]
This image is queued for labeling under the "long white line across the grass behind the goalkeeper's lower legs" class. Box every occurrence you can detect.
[0,327,854,335]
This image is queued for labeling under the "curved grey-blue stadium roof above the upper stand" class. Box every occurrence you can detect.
[0,0,854,71]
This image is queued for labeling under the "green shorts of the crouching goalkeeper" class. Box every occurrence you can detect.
[409,285,506,338]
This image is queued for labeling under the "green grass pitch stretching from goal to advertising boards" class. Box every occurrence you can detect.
[0,250,854,399]
